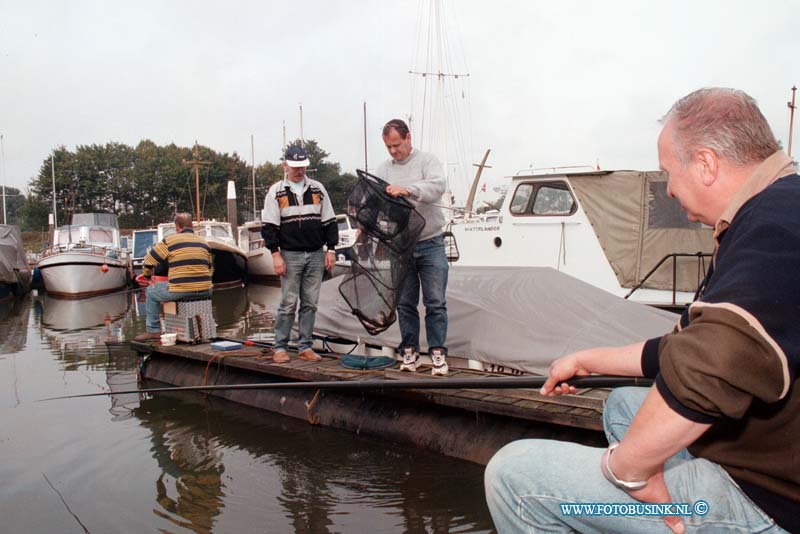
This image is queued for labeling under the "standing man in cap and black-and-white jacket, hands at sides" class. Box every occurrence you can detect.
[261,145,339,363]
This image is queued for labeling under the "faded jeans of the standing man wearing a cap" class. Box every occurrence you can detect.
[275,249,325,352]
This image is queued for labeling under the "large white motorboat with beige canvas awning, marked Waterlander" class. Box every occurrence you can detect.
[447,171,714,307]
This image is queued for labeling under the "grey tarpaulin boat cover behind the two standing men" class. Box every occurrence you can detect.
[314,267,678,374]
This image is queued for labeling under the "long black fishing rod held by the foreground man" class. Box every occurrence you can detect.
[37,375,653,402]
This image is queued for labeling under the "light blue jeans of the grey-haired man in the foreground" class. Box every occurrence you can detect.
[485,388,785,534]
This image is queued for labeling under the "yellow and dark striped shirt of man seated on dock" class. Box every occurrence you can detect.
[142,228,213,293]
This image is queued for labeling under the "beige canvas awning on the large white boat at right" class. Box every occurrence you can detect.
[569,171,714,292]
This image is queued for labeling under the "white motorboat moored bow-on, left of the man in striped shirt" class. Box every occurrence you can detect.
[37,213,129,298]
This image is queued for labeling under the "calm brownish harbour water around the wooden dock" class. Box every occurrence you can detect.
[0,292,492,533]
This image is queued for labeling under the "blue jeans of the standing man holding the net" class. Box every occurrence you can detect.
[397,235,450,351]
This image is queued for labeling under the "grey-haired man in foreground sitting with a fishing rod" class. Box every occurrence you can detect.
[485,88,800,533]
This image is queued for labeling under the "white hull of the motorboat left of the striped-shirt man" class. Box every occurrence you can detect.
[37,251,128,298]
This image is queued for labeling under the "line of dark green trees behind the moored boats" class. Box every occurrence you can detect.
[6,139,357,231]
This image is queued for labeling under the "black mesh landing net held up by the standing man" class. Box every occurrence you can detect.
[339,170,425,335]
